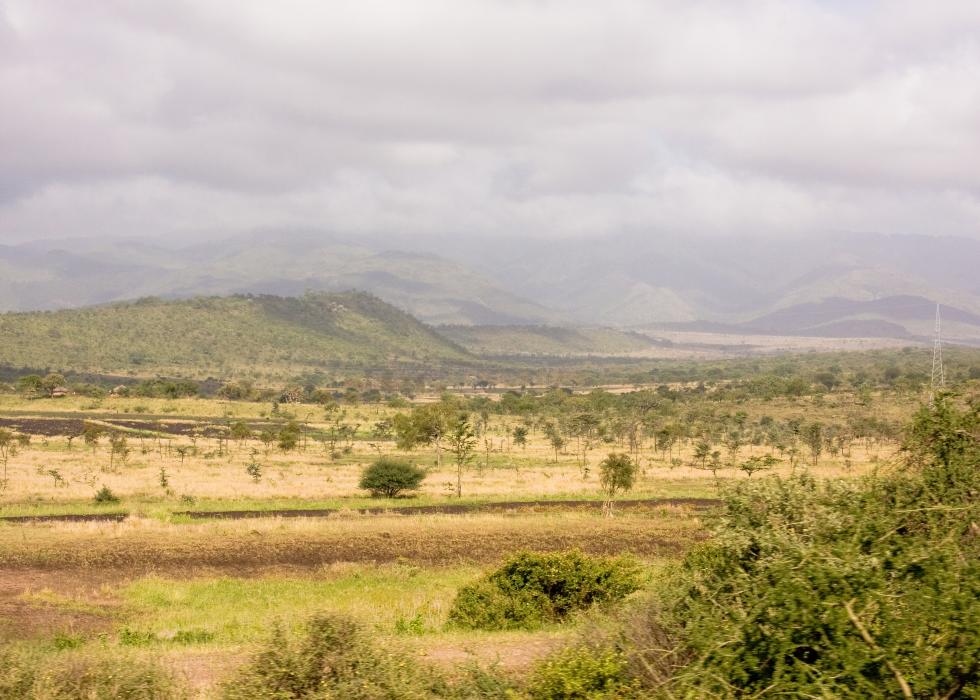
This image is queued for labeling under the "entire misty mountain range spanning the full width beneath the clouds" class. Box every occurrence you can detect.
[0,231,980,338]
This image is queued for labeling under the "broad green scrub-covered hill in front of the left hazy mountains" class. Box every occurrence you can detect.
[0,292,478,386]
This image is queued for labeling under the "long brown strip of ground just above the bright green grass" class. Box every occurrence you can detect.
[0,514,703,575]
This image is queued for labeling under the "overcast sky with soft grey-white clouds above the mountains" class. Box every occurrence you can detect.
[0,0,980,242]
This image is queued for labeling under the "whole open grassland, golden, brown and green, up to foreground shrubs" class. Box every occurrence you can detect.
[0,388,916,698]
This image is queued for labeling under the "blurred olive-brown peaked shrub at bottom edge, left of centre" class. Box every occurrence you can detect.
[222,614,448,700]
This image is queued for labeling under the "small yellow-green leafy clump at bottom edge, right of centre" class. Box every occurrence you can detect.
[527,645,641,700]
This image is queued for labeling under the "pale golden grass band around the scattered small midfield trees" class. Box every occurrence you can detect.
[0,397,903,514]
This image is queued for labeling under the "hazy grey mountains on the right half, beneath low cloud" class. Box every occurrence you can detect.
[438,234,980,325]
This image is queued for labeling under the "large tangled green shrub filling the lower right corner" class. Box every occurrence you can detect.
[634,395,980,698]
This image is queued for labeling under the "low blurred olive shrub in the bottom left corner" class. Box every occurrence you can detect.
[0,649,189,700]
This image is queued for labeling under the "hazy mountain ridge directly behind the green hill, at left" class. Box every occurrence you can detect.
[0,234,561,323]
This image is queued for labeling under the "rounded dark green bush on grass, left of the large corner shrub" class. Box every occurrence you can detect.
[449,550,641,630]
